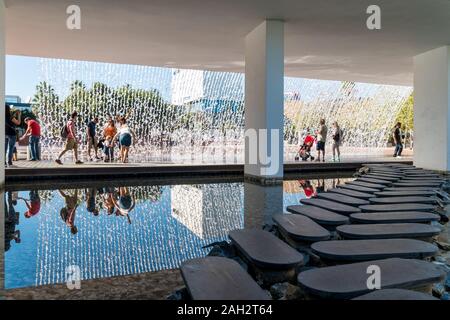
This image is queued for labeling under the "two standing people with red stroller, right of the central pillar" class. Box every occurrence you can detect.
[296,119,343,162]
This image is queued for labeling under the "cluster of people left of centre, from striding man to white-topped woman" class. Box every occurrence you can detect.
[55,112,136,164]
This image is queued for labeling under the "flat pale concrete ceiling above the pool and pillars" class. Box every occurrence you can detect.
[5,0,450,85]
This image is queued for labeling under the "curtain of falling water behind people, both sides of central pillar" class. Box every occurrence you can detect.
[30,59,412,163]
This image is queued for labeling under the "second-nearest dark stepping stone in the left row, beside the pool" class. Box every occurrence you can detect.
[228,229,303,270]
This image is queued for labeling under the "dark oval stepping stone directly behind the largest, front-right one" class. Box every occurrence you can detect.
[311,239,439,262]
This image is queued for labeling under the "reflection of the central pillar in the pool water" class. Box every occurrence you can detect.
[244,182,283,228]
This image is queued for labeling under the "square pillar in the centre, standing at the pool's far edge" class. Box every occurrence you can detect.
[245,20,284,180]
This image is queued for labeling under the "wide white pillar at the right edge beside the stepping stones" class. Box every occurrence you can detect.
[414,46,450,171]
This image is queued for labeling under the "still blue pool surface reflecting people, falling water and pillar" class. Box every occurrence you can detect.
[4,176,348,288]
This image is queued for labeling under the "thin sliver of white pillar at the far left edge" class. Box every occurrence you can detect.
[0,0,5,189]
